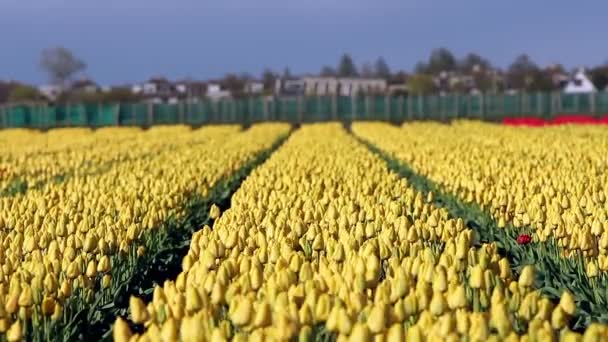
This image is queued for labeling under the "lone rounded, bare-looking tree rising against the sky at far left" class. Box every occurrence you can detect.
[40,47,86,88]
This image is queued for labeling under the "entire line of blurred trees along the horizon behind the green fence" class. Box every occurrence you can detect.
[0,47,608,103]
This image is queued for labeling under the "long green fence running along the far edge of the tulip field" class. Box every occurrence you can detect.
[0,92,608,129]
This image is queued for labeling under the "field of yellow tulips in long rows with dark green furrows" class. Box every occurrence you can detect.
[0,121,608,342]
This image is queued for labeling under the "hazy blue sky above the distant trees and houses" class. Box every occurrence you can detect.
[0,0,608,85]
